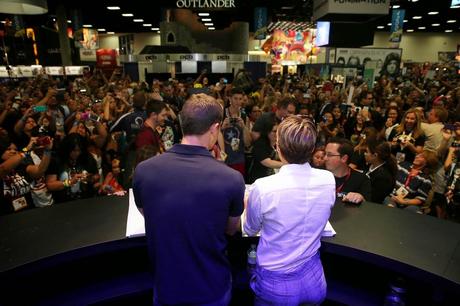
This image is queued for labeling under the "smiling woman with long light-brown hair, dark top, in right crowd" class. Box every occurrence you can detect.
[388,108,425,163]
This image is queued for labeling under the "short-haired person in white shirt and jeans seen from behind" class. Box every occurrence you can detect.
[244,116,335,305]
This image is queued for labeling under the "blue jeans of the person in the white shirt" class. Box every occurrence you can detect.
[251,252,327,306]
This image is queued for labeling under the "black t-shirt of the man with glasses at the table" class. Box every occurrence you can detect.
[335,168,371,201]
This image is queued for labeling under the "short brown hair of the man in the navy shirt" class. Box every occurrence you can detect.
[179,93,224,135]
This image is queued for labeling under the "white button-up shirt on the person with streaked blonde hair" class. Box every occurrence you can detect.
[244,163,335,272]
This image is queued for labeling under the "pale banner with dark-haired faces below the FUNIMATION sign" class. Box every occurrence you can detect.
[335,48,402,77]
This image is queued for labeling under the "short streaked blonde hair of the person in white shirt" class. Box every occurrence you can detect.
[277,116,317,164]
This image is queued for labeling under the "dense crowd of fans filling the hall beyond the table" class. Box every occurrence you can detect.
[0,65,460,220]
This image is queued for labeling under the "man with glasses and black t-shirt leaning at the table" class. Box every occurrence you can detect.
[324,138,371,204]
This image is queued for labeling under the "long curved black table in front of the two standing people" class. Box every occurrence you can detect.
[0,196,460,305]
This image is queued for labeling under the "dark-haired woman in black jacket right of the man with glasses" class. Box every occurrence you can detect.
[364,139,398,204]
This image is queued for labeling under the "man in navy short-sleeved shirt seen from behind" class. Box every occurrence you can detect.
[133,94,245,306]
